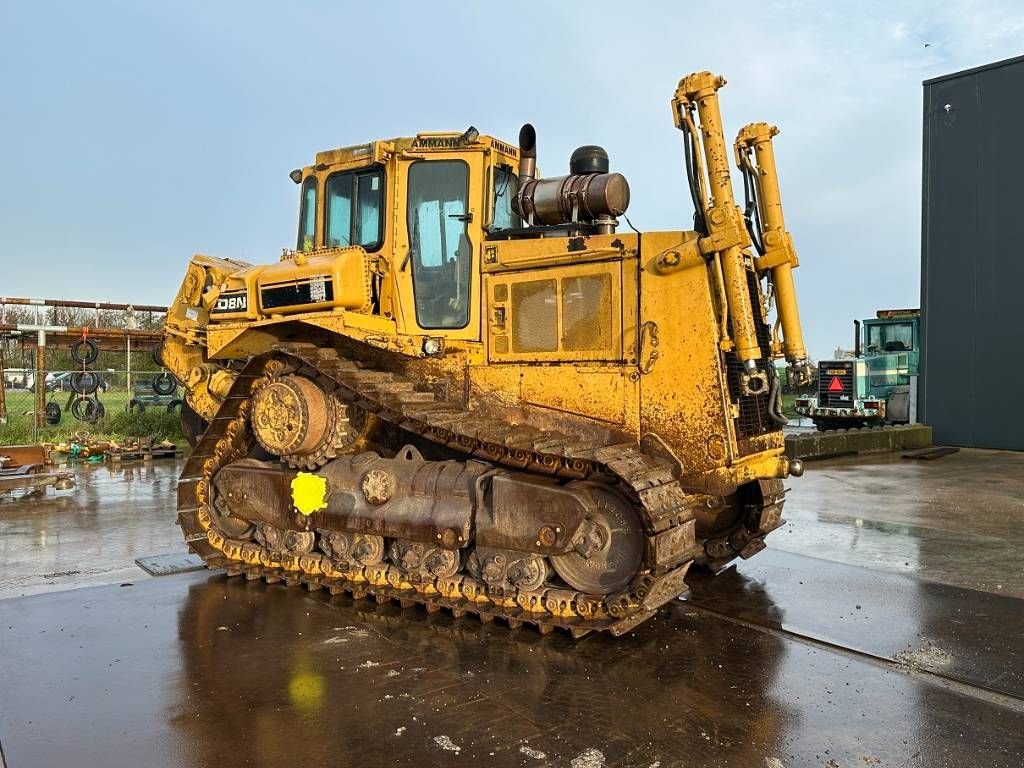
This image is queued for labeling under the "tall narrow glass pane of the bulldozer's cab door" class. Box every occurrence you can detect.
[407,160,473,329]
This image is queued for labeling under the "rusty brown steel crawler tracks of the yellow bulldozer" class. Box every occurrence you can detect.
[177,343,782,637]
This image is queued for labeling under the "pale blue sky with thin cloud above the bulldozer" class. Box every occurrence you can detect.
[0,0,1024,358]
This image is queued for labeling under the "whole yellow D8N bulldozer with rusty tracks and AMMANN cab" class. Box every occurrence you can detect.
[160,72,807,636]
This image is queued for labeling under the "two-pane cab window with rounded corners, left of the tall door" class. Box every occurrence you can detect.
[324,169,384,251]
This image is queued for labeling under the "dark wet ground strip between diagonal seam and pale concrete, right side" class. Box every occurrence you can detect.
[688,550,1024,700]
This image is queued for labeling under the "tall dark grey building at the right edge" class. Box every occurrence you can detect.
[918,56,1024,451]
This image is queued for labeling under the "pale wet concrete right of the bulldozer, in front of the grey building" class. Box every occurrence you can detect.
[769,450,1024,597]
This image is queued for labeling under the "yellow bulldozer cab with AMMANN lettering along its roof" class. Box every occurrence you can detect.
[292,130,520,340]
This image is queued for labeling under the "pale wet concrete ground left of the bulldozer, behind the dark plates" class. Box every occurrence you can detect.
[0,461,184,598]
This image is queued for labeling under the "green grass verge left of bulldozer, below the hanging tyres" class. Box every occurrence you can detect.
[0,388,184,445]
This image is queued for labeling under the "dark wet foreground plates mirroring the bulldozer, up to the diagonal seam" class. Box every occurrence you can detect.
[0,574,1024,768]
